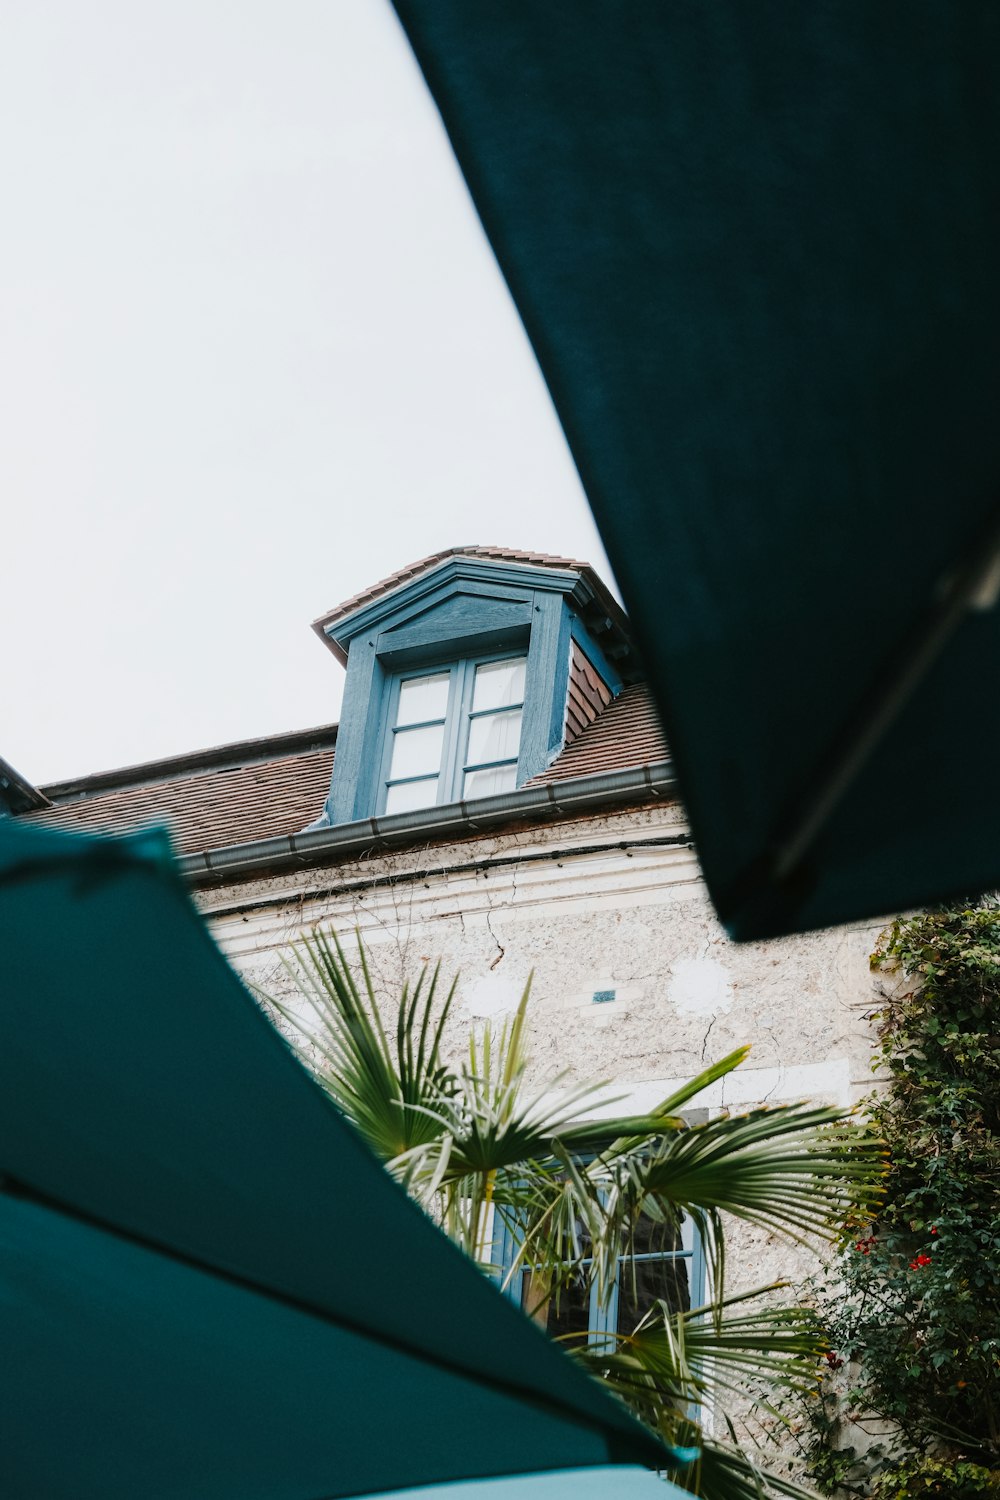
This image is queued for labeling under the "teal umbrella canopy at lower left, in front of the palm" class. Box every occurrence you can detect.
[0,821,669,1500]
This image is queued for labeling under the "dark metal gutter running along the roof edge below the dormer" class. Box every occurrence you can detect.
[177,761,678,885]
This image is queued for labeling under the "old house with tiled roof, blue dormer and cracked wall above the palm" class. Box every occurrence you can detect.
[13,548,879,1344]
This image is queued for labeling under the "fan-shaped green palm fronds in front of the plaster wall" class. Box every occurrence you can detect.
[268,933,883,1500]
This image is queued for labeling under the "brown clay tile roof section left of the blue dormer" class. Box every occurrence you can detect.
[24,726,336,854]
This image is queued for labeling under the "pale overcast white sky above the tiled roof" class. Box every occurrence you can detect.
[0,0,610,783]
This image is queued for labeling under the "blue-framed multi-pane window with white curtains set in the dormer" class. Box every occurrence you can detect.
[376,653,528,813]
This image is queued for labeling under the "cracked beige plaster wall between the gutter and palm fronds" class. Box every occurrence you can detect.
[199,806,882,1106]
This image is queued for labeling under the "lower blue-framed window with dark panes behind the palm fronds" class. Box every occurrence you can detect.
[493,1214,705,1350]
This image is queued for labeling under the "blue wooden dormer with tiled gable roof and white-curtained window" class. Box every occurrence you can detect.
[313,548,637,824]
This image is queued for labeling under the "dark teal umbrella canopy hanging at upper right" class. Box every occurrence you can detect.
[396,0,1000,938]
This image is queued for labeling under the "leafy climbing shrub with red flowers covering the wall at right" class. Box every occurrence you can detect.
[779,905,1000,1500]
